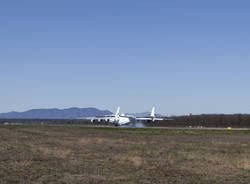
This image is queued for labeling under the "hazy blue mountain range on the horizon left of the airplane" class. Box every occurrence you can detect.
[0,107,113,119]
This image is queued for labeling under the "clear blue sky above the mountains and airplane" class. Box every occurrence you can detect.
[0,0,250,114]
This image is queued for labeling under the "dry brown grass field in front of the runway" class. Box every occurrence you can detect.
[0,125,250,184]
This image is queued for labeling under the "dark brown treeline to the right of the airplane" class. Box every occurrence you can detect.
[151,114,250,128]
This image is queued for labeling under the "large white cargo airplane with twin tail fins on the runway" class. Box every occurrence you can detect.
[91,107,163,126]
